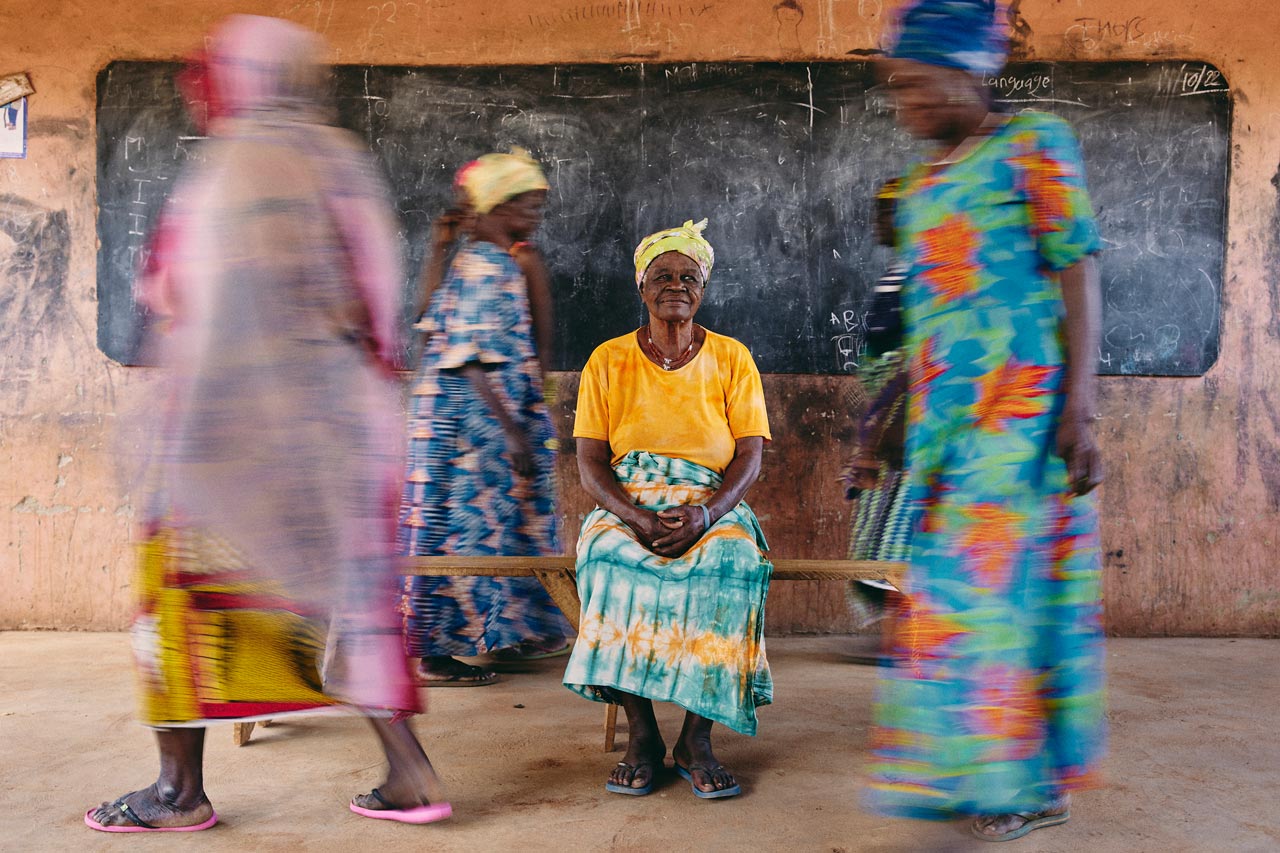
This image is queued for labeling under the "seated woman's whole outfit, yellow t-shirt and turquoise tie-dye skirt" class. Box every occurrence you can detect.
[564,329,773,735]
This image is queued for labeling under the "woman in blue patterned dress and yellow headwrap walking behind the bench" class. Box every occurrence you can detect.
[398,151,568,686]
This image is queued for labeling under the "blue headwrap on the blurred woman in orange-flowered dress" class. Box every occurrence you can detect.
[888,0,1009,74]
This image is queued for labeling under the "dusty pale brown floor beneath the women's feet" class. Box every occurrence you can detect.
[0,633,1280,853]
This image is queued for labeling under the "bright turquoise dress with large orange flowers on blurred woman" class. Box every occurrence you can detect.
[869,113,1106,817]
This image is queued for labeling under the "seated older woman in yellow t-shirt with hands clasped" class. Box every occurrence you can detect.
[564,220,773,798]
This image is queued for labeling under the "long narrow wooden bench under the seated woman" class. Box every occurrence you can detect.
[232,556,906,752]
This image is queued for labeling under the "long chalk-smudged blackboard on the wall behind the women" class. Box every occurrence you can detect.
[97,61,1230,375]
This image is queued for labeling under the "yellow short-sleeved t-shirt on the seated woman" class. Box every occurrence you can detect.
[573,330,771,474]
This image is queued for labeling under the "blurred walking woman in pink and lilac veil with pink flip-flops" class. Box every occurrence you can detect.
[84,15,451,833]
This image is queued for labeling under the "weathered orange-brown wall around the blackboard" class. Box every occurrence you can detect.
[0,0,1280,635]
